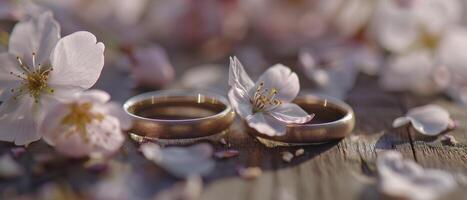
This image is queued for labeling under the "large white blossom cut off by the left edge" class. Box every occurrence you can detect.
[0,12,104,145]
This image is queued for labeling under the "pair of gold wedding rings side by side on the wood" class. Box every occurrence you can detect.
[123,90,355,144]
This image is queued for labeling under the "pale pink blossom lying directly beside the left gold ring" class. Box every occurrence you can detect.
[41,90,131,157]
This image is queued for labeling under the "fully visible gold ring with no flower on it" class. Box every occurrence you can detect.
[123,90,235,139]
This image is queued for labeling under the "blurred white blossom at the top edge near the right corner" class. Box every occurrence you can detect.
[372,0,461,53]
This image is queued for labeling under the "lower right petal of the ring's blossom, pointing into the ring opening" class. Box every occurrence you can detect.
[270,103,314,124]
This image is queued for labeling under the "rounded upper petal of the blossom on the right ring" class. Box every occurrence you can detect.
[255,64,300,103]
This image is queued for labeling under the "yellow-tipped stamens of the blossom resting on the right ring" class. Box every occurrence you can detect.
[251,82,282,113]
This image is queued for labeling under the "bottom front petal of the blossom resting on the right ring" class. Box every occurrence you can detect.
[246,113,287,136]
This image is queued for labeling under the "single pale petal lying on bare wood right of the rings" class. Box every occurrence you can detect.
[392,104,453,136]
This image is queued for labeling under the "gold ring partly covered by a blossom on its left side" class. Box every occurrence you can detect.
[247,94,355,144]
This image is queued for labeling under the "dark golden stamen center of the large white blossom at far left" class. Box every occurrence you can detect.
[10,53,54,103]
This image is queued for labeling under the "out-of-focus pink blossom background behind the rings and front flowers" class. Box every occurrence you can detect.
[0,0,467,103]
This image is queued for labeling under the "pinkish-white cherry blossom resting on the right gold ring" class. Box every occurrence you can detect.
[229,57,313,136]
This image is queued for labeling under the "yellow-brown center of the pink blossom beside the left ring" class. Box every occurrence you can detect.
[61,102,104,142]
